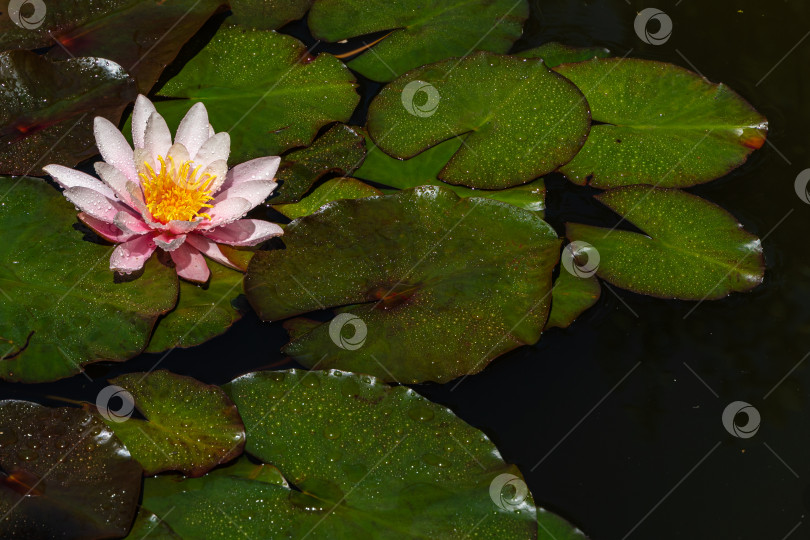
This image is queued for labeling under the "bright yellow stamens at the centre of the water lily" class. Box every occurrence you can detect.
[139,156,216,224]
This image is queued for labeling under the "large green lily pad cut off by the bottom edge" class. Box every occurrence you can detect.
[144,370,537,538]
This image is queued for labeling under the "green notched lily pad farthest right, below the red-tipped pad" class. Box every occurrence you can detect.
[566,186,765,300]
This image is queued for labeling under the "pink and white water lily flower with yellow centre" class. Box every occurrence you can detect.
[43,96,283,282]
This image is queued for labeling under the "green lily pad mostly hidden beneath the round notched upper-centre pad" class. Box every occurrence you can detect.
[355,138,546,217]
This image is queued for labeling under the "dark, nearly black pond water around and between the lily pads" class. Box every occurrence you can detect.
[0,0,810,540]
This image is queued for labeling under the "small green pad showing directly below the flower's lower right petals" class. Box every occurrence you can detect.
[145,250,253,353]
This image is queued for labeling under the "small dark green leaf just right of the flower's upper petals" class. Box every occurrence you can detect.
[271,124,366,204]
